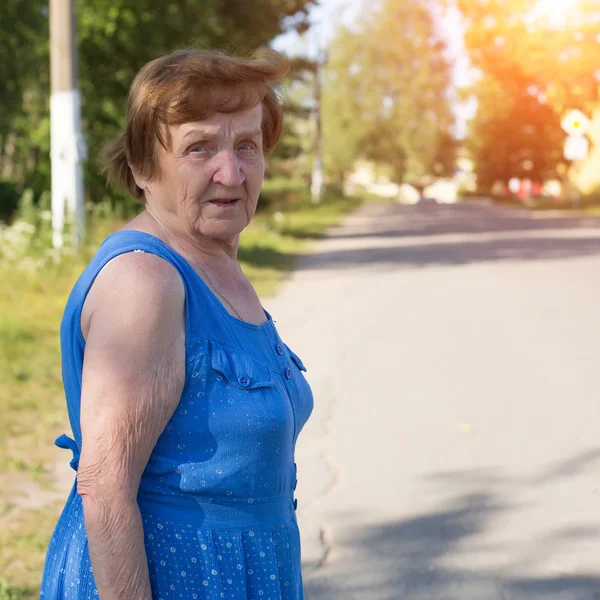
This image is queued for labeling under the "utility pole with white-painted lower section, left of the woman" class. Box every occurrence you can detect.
[50,0,87,251]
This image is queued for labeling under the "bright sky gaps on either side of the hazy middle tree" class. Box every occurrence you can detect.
[273,0,477,138]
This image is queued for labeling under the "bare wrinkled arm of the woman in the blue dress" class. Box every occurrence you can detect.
[77,252,185,600]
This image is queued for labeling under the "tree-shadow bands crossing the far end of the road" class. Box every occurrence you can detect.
[297,205,600,270]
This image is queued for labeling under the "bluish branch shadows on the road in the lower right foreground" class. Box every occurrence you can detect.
[306,449,600,600]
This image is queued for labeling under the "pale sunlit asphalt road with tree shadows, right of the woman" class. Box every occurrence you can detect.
[265,203,600,600]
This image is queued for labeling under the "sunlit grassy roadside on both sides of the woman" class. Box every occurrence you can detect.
[0,192,360,600]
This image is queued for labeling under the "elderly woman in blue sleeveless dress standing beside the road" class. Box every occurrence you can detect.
[41,50,312,600]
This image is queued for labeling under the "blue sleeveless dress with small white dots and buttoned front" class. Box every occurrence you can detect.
[40,231,313,600]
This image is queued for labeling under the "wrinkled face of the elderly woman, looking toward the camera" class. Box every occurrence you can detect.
[145,105,265,239]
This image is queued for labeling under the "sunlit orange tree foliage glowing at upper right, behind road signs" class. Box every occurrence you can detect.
[458,0,600,186]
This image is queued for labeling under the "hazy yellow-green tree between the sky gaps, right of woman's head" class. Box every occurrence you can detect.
[323,0,452,181]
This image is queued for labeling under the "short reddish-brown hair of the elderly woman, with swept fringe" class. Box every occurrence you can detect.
[101,48,288,199]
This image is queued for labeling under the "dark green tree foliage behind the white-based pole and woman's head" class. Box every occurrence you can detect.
[0,0,310,211]
